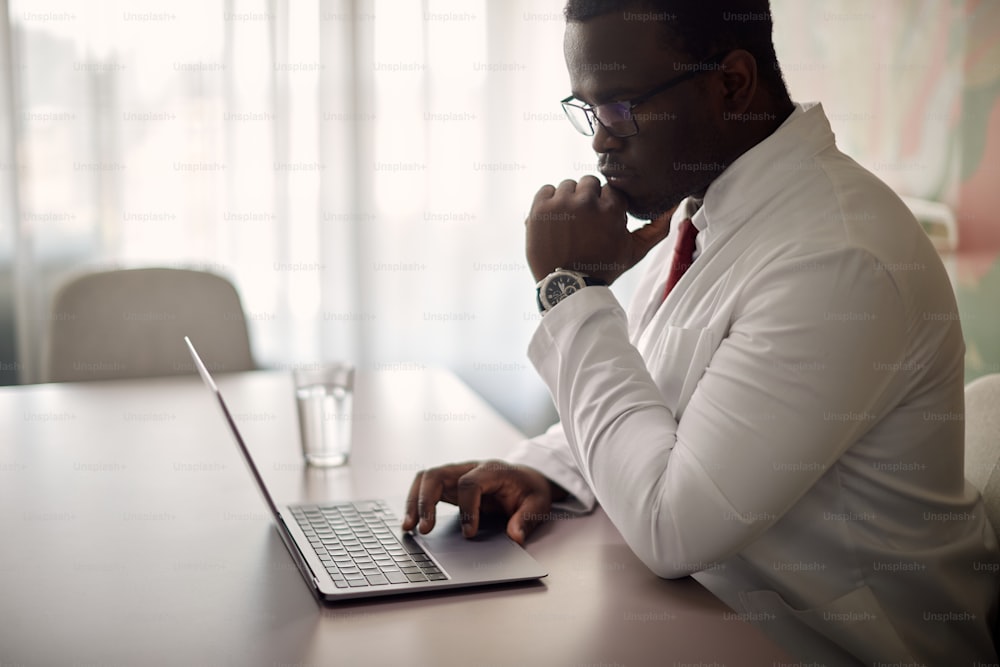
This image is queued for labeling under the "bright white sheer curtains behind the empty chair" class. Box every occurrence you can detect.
[0,0,612,432]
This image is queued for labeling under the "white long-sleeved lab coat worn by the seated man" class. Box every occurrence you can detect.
[509,105,1000,666]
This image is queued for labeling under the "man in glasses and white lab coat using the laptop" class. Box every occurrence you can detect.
[403,0,1000,666]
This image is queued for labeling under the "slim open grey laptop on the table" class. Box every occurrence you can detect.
[184,336,547,602]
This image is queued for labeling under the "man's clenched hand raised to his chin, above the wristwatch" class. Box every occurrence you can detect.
[524,176,670,285]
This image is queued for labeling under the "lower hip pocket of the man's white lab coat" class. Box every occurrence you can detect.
[740,586,912,665]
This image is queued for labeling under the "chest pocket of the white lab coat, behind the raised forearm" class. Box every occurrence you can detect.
[640,326,715,419]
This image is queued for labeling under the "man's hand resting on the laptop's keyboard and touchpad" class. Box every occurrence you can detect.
[403,460,566,545]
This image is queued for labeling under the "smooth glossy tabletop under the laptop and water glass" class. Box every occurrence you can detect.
[0,368,791,667]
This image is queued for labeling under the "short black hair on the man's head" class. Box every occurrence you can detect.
[564,0,788,97]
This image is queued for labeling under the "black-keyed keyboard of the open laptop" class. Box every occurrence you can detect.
[290,501,448,588]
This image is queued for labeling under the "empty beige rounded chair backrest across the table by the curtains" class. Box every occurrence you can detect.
[44,268,254,382]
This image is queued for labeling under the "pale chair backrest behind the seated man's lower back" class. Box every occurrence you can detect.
[965,373,1000,534]
